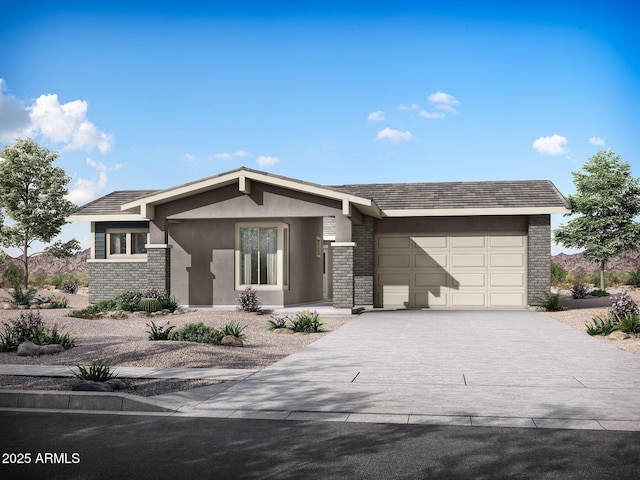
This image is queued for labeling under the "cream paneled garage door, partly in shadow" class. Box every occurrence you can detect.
[375,234,527,308]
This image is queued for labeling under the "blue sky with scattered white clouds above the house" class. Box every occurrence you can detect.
[0,0,640,253]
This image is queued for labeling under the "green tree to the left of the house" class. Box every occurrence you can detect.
[0,139,80,287]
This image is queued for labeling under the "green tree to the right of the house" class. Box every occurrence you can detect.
[553,150,640,290]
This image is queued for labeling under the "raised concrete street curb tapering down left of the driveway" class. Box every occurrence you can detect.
[0,390,175,412]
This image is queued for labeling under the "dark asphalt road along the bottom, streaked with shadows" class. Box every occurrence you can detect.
[0,411,640,480]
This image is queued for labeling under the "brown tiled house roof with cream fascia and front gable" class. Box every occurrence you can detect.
[68,167,569,221]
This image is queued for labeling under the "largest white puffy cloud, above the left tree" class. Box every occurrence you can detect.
[0,79,113,153]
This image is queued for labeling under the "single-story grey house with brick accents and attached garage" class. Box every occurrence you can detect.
[68,167,569,309]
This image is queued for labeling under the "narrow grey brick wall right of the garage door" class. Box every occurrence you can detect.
[527,215,551,305]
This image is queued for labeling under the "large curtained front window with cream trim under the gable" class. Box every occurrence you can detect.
[236,224,288,288]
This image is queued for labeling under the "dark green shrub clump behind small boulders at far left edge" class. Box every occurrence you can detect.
[0,310,75,352]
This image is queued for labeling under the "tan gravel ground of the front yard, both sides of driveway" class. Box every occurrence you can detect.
[0,289,640,396]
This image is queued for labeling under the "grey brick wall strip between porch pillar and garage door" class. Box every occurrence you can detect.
[352,217,374,305]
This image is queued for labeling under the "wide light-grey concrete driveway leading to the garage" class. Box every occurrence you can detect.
[169,310,640,430]
